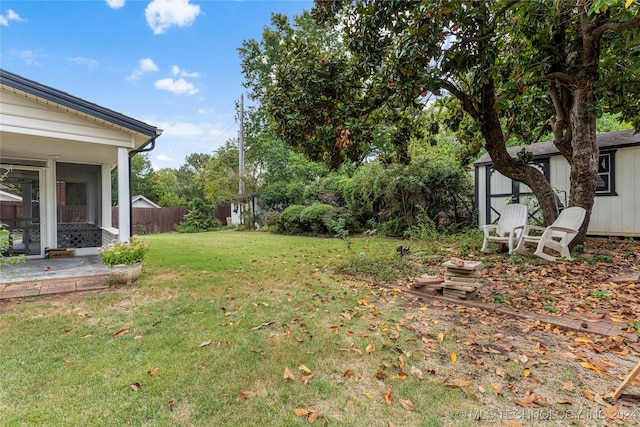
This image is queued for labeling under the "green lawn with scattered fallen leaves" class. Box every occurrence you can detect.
[0,232,482,426]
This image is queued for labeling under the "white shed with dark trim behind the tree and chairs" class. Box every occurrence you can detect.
[474,129,640,237]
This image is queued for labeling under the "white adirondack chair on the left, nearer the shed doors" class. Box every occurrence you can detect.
[481,203,527,254]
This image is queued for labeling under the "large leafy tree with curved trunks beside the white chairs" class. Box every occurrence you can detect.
[282,0,640,242]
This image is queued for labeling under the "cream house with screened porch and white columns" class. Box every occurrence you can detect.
[0,69,162,257]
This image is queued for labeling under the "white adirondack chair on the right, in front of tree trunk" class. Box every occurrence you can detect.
[516,206,586,261]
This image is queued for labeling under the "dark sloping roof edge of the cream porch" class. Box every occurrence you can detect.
[0,68,162,137]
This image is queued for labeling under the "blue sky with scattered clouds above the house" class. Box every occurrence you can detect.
[0,0,313,168]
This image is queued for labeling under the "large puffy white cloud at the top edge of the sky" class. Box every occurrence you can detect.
[144,0,200,34]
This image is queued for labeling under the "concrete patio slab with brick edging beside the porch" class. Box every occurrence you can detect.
[0,255,110,300]
